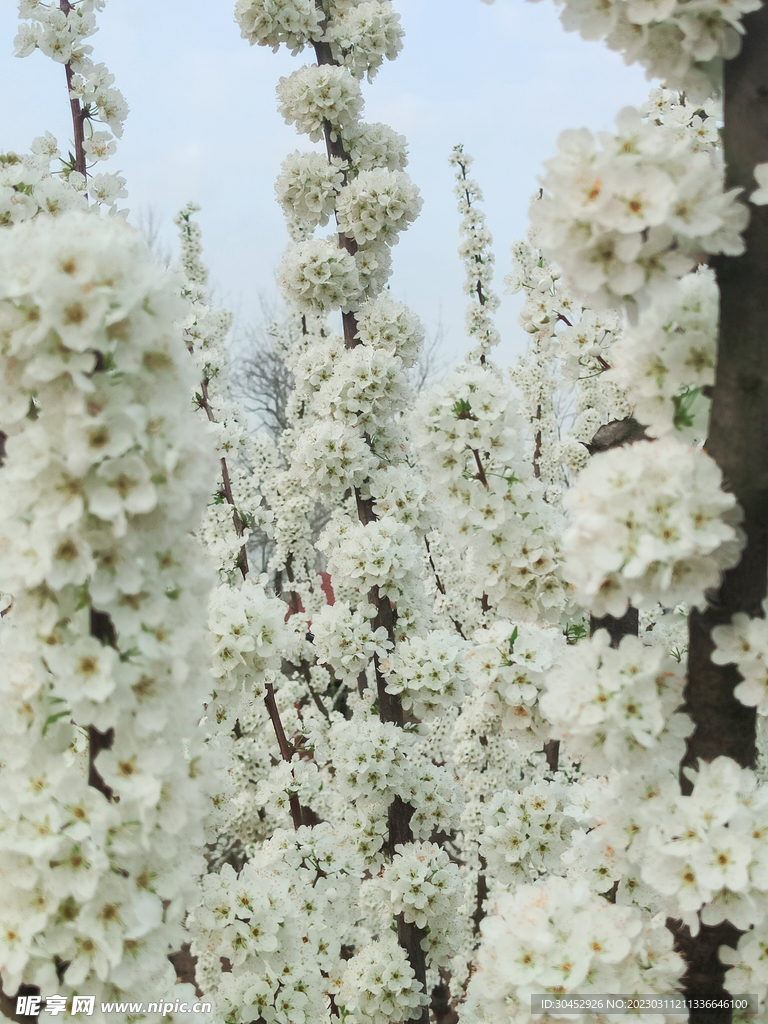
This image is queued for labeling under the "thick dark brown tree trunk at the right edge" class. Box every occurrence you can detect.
[677,7,768,1024]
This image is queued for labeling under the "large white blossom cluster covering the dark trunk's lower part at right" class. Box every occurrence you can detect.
[563,757,768,936]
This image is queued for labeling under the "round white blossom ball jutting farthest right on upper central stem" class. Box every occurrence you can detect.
[336,167,422,246]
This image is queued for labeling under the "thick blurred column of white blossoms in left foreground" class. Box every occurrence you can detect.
[0,213,215,1007]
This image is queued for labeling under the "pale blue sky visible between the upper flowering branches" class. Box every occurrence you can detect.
[0,0,649,364]
